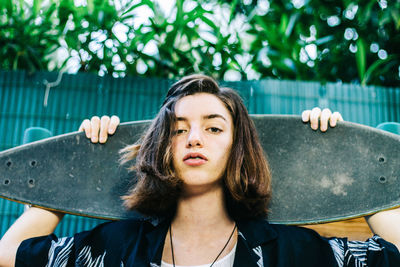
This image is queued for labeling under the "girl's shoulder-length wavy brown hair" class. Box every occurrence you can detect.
[121,75,270,219]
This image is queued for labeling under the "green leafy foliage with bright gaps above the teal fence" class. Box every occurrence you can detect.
[0,0,400,86]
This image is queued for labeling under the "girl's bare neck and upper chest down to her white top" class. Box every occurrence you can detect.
[162,186,237,265]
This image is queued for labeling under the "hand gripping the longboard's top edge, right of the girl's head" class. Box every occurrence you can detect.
[301,107,343,132]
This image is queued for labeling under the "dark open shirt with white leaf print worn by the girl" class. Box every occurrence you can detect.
[15,219,400,267]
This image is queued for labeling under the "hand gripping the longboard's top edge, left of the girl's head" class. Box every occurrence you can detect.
[79,115,120,144]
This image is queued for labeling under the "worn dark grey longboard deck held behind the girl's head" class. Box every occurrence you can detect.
[0,115,400,224]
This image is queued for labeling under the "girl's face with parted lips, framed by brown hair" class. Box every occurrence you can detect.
[172,93,233,192]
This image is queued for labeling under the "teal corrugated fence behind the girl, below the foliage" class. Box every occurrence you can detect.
[0,71,400,236]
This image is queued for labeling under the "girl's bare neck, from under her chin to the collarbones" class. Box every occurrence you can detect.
[172,186,234,232]
